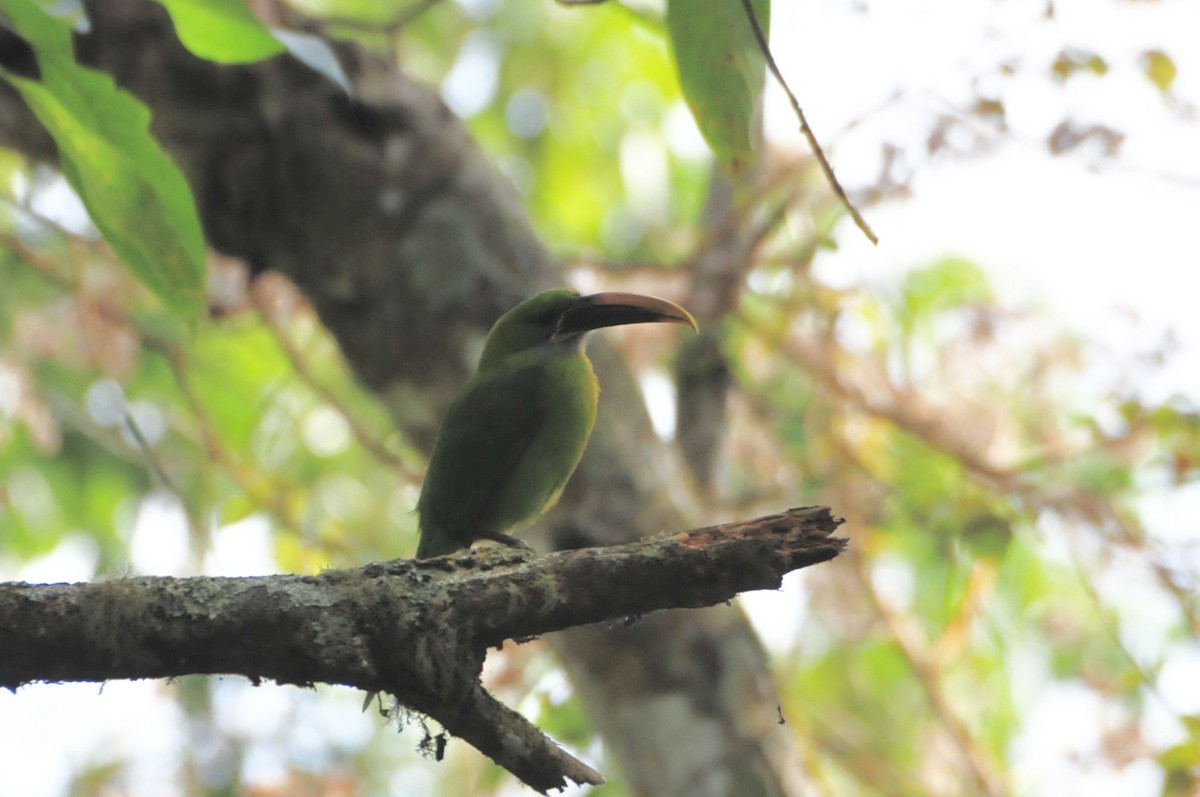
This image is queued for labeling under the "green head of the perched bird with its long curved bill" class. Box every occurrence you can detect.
[479,288,698,368]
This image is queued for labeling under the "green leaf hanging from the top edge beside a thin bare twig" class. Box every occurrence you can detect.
[667,0,770,170]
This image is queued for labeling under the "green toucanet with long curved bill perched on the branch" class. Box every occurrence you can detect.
[416,288,697,559]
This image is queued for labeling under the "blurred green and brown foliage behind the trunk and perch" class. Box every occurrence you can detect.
[0,0,1200,796]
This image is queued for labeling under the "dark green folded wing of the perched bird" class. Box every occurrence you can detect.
[418,365,574,556]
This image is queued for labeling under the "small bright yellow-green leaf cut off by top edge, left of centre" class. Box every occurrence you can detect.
[158,0,284,64]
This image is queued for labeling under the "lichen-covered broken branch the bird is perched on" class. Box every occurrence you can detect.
[0,507,846,792]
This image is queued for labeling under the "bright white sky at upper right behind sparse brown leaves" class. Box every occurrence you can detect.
[767,0,1200,365]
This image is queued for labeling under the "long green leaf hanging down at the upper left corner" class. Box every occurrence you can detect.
[0,0,204,318]
